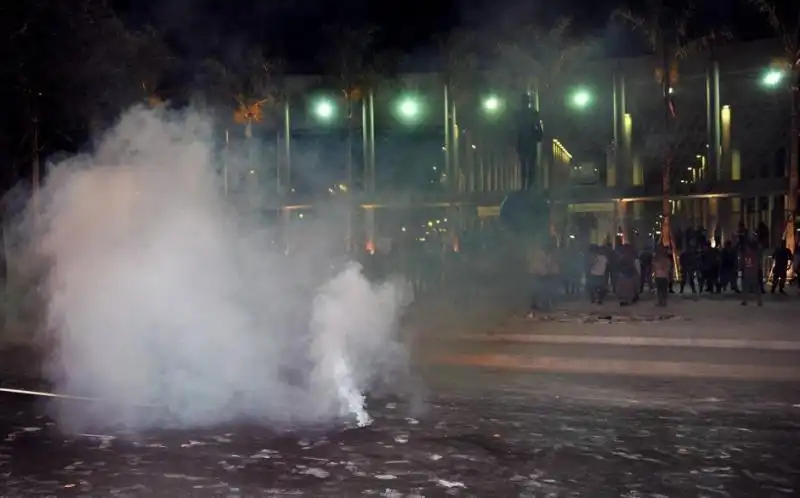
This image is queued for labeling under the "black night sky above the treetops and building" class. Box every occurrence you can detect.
[112,0,769,71]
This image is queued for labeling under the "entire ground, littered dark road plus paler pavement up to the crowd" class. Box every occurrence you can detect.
[0,288,800,498]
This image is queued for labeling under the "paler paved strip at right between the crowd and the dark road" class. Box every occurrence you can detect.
[417,296,800,381]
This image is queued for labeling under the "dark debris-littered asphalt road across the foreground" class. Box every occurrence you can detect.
[0,367,800,498]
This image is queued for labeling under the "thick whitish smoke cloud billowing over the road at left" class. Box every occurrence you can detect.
[25,109,408,430]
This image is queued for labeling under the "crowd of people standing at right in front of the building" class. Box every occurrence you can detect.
[528,225,800,313]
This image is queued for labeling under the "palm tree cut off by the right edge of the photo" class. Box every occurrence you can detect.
[749,0,800,251]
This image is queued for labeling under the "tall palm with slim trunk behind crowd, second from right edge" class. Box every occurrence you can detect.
[611,0,729,246]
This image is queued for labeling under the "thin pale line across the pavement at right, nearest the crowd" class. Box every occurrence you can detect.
[467,334,800,351]
